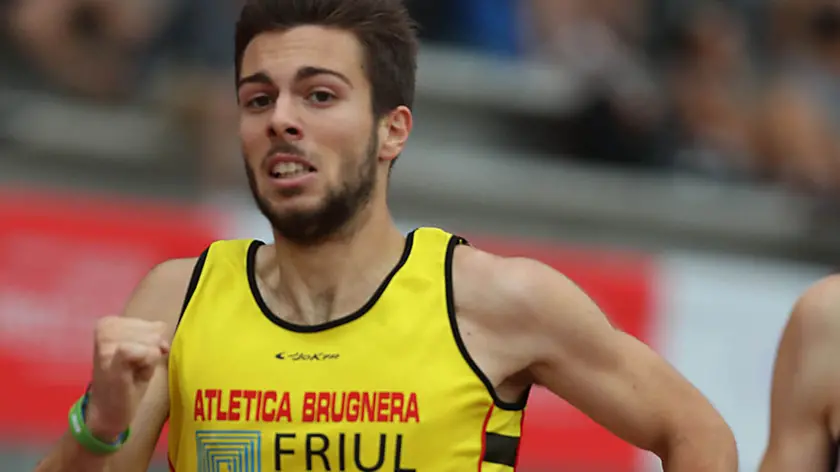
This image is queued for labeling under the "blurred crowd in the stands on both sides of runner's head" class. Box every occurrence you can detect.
[0,0,840,196]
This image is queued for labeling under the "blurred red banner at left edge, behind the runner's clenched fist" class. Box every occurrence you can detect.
[0,188,216,442]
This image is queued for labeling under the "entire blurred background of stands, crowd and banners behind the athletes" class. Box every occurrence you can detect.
[0,0,840,472]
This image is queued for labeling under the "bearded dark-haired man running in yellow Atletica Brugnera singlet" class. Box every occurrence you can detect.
[37,0,737,472]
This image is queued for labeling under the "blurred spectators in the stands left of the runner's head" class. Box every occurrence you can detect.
[9,0,241,194]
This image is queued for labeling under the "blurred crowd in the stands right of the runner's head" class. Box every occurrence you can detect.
[414,0,840,195]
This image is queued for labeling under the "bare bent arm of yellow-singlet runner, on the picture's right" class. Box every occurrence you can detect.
[493,259,738,472]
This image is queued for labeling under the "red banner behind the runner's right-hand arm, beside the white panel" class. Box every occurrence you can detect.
[471,238,656,472]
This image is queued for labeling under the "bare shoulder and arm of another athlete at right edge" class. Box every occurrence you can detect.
[761,275,840,472]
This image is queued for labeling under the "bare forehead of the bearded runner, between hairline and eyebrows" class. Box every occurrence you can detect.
[242,26,364,79]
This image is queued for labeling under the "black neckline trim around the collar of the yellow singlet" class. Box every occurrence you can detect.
[246,231,414,333]
